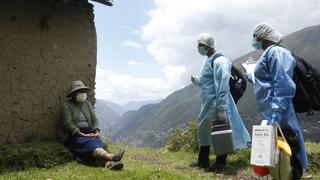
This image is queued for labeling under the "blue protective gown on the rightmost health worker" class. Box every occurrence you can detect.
[254,46,308,169]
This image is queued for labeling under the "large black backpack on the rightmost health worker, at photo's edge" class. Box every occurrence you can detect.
[269,45,320,115]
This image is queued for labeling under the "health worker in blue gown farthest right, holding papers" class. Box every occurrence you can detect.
[247,23,308,170]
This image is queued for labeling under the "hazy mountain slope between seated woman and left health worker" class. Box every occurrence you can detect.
[111,86,200,147]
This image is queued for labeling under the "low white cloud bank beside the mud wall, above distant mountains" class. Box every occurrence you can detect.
[95,67,181,104]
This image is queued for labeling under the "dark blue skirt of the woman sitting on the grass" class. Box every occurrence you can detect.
[64,128,105,163]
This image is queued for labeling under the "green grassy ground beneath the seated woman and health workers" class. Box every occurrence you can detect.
[0,143,320,180]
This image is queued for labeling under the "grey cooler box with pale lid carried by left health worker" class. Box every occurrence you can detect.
[211,129,236,155]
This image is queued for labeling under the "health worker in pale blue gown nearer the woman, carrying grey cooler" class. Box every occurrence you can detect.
[190,33,251,172]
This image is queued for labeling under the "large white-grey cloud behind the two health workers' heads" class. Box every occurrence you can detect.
[142,0,320,85]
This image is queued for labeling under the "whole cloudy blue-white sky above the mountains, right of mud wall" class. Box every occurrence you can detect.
[93,0,320,104]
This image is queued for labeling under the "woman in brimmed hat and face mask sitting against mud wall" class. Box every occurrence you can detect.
[58,81,124,170]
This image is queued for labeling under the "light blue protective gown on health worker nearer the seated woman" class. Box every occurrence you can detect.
[194,52,251,149]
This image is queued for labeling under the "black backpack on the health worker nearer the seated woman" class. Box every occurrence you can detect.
[211,53,247,103]
